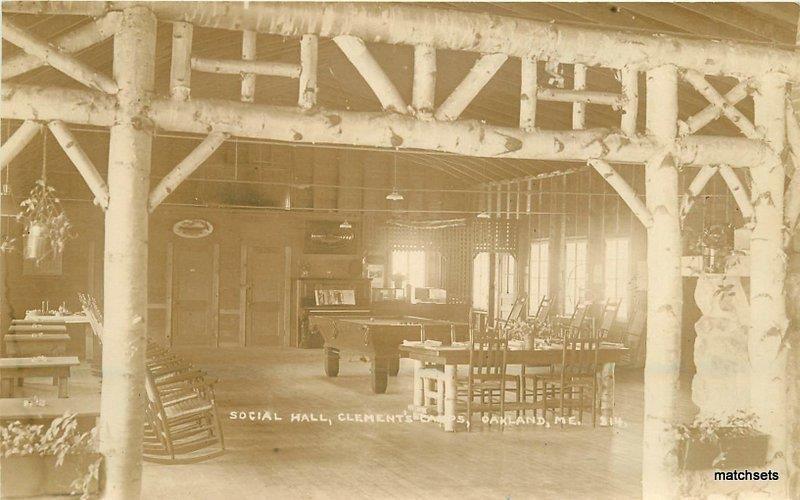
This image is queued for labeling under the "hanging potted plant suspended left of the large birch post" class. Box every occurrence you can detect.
[17,179,73,261]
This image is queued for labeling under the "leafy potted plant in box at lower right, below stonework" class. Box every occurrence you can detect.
[677,410,769,470]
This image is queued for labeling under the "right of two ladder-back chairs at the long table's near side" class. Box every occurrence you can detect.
[531,332,600,427]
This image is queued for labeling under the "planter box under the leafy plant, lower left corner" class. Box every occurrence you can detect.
[0,453,103,498]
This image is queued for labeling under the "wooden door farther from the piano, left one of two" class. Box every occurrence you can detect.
[172,243,216,346]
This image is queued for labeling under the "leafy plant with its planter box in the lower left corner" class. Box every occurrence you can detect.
[0,414,102,498]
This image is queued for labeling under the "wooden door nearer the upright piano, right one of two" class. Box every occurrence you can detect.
[246,245,286,346]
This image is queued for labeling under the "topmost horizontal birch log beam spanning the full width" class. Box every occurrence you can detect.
[3,1,800,81]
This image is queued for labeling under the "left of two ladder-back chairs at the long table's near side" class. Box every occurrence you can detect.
[457,330,522,430]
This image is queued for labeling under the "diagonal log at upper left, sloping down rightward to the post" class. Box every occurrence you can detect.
[3,16,117,94]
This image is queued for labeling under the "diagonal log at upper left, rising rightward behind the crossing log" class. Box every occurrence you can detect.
[0,12,120,80]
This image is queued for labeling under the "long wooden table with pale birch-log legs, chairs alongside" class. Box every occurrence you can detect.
[400,343,628,432]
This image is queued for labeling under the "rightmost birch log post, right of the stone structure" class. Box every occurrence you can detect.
[748,73,789,492]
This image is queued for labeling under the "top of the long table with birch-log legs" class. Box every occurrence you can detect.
[400,342,628,366]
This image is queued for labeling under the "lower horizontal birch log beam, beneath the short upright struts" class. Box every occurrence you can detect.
[0,84,776,167]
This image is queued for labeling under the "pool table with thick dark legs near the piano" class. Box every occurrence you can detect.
[308,315,468,394]
